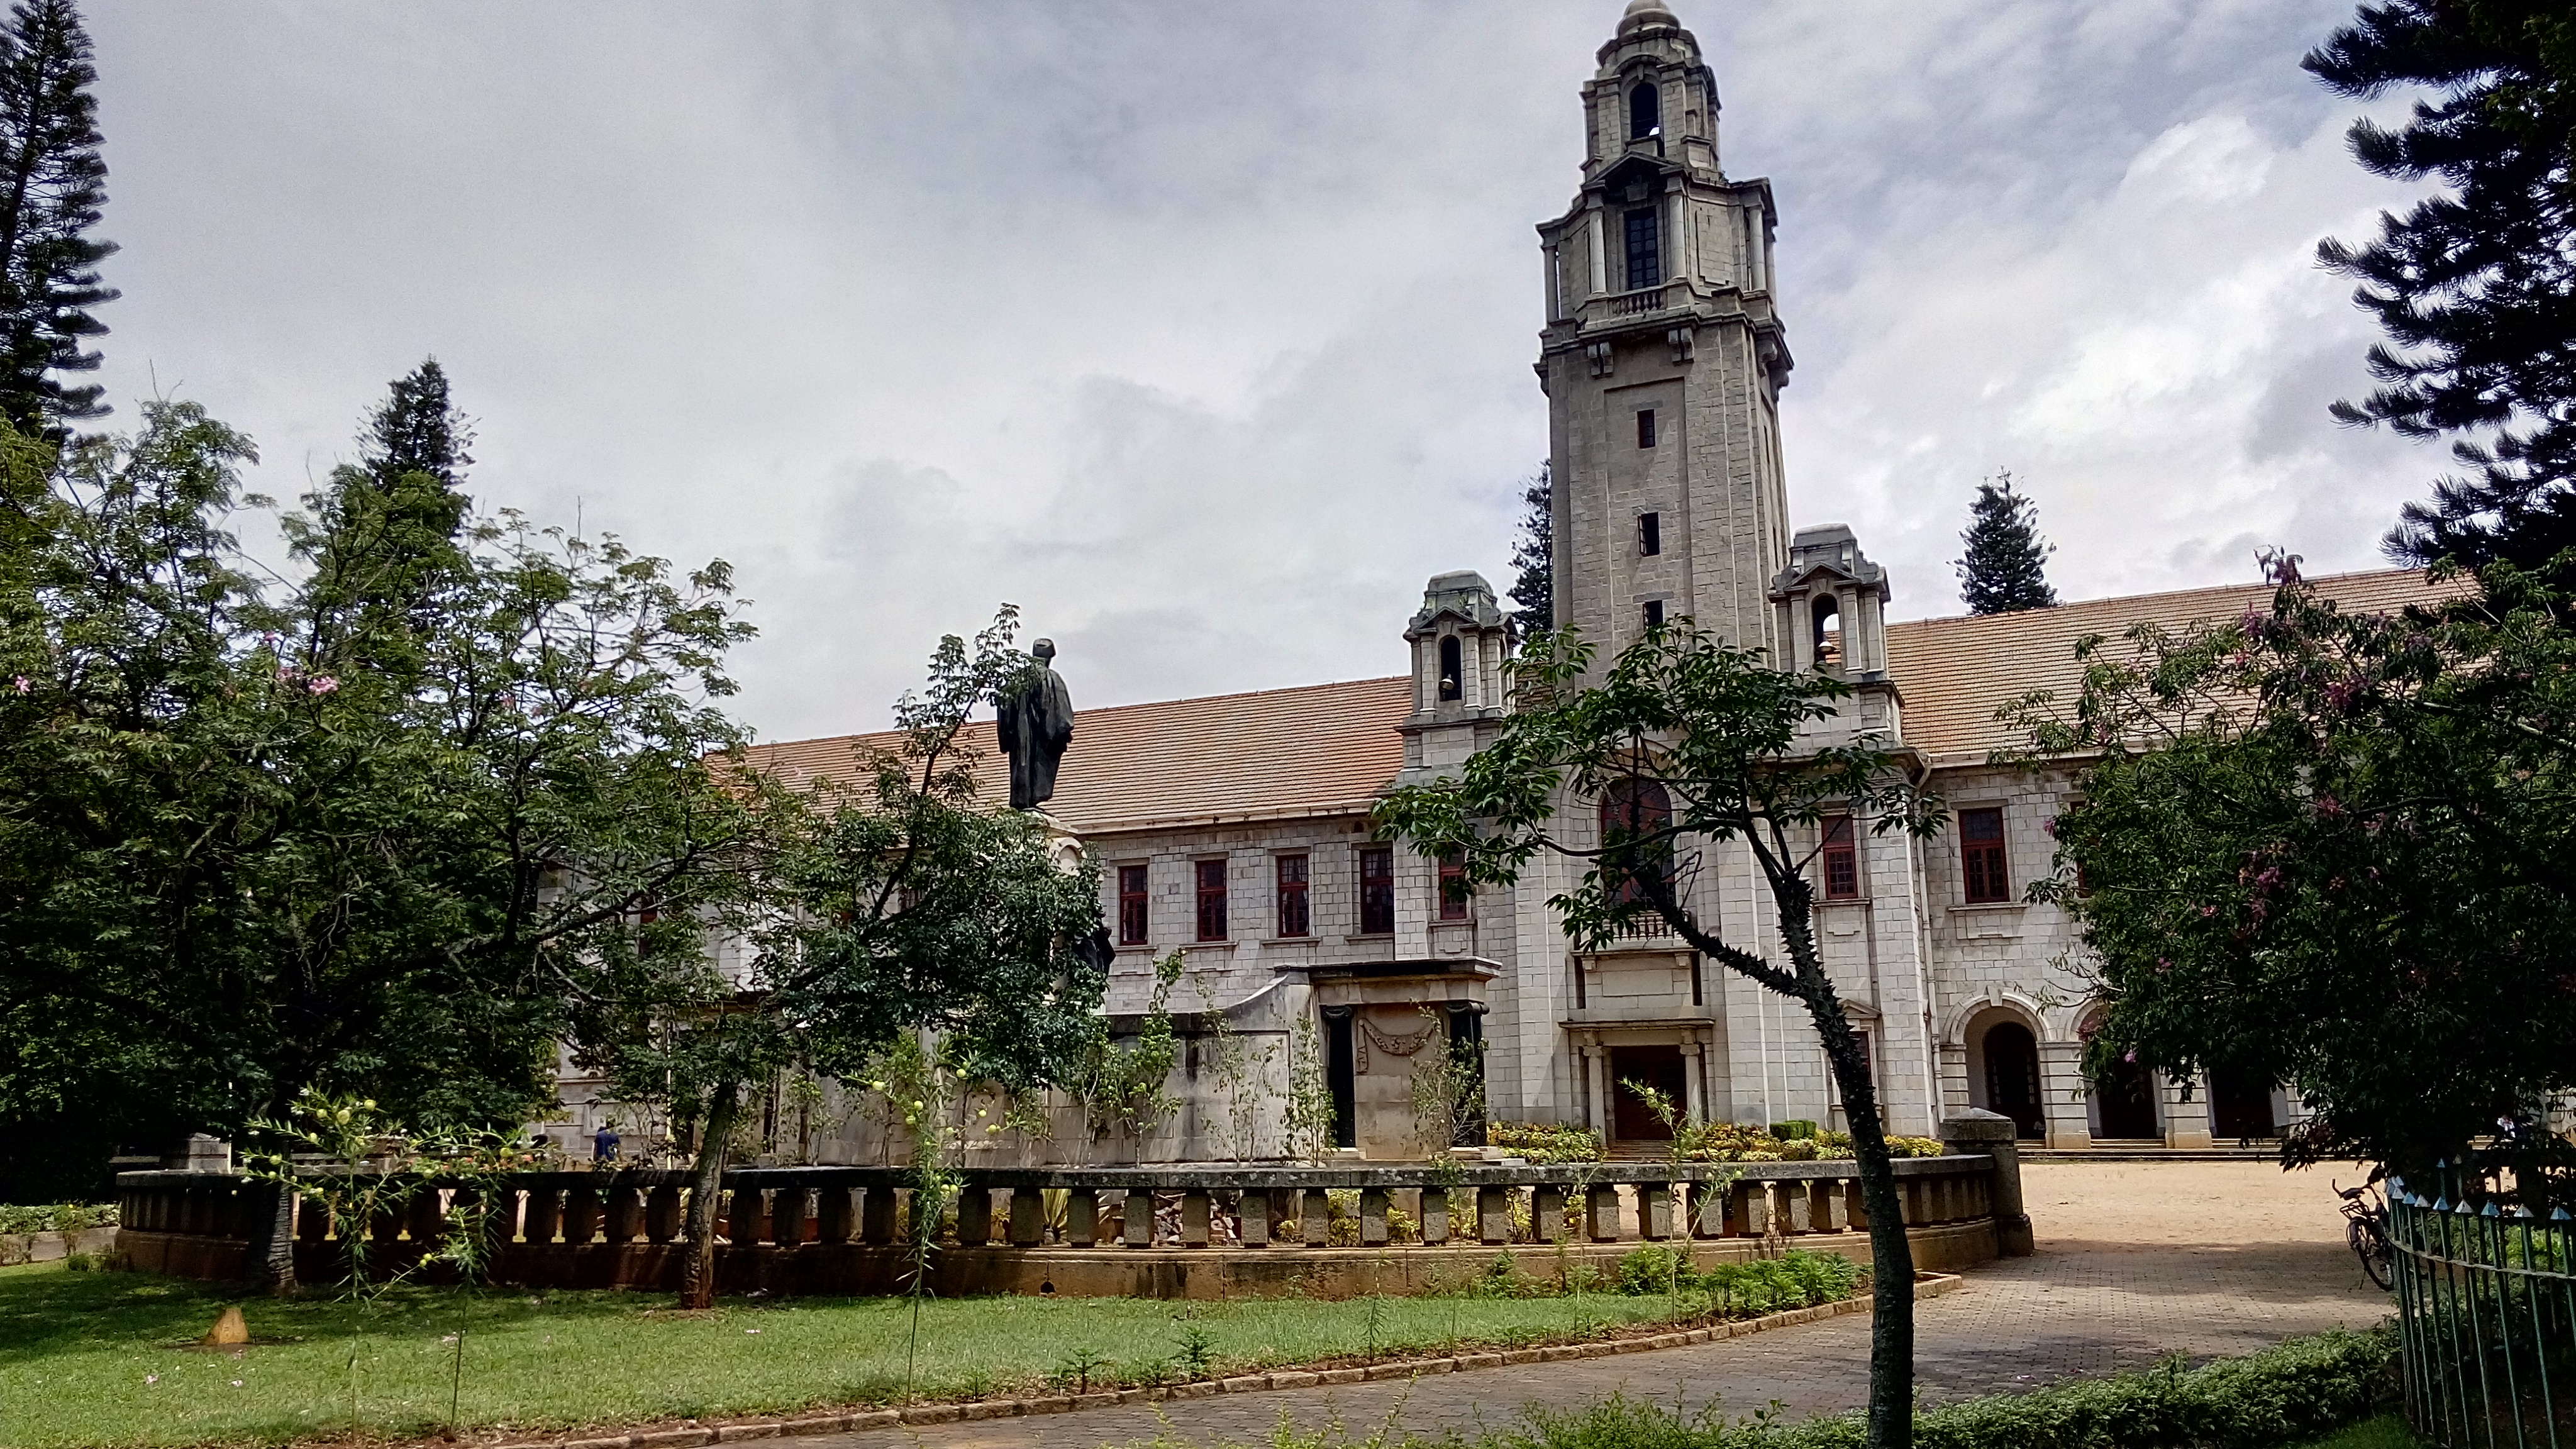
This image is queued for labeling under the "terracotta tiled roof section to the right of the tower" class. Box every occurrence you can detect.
[1888,570,2473,758]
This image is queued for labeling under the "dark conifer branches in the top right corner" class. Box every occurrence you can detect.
[2306,0,2576,567]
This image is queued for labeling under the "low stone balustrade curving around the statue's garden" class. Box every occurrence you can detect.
[118,1124,2028,1297]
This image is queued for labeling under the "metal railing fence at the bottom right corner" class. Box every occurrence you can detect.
[2388,1160,2576,1449]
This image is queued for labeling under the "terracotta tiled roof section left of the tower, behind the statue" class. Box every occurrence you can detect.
[752,675,1412,835]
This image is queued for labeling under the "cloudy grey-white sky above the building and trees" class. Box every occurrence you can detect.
[90,0,2442,737]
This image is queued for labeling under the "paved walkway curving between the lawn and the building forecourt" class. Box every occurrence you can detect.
[775,1163,2388,1449]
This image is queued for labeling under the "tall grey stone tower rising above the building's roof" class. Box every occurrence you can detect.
[1538,0,1790,657]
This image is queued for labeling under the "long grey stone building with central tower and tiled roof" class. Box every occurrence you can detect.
[574,0,2424,1160]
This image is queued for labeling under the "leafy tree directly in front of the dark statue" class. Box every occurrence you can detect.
[572,609,1110,1304]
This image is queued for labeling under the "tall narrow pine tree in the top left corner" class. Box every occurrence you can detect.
[0,0,116,438]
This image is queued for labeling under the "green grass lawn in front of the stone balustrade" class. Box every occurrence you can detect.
[0,1263,1664,1449]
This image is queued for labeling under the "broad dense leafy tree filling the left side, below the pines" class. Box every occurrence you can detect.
[0,405,765,1276]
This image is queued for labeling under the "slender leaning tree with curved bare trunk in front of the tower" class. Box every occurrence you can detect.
[1375,624,1942,1449]
